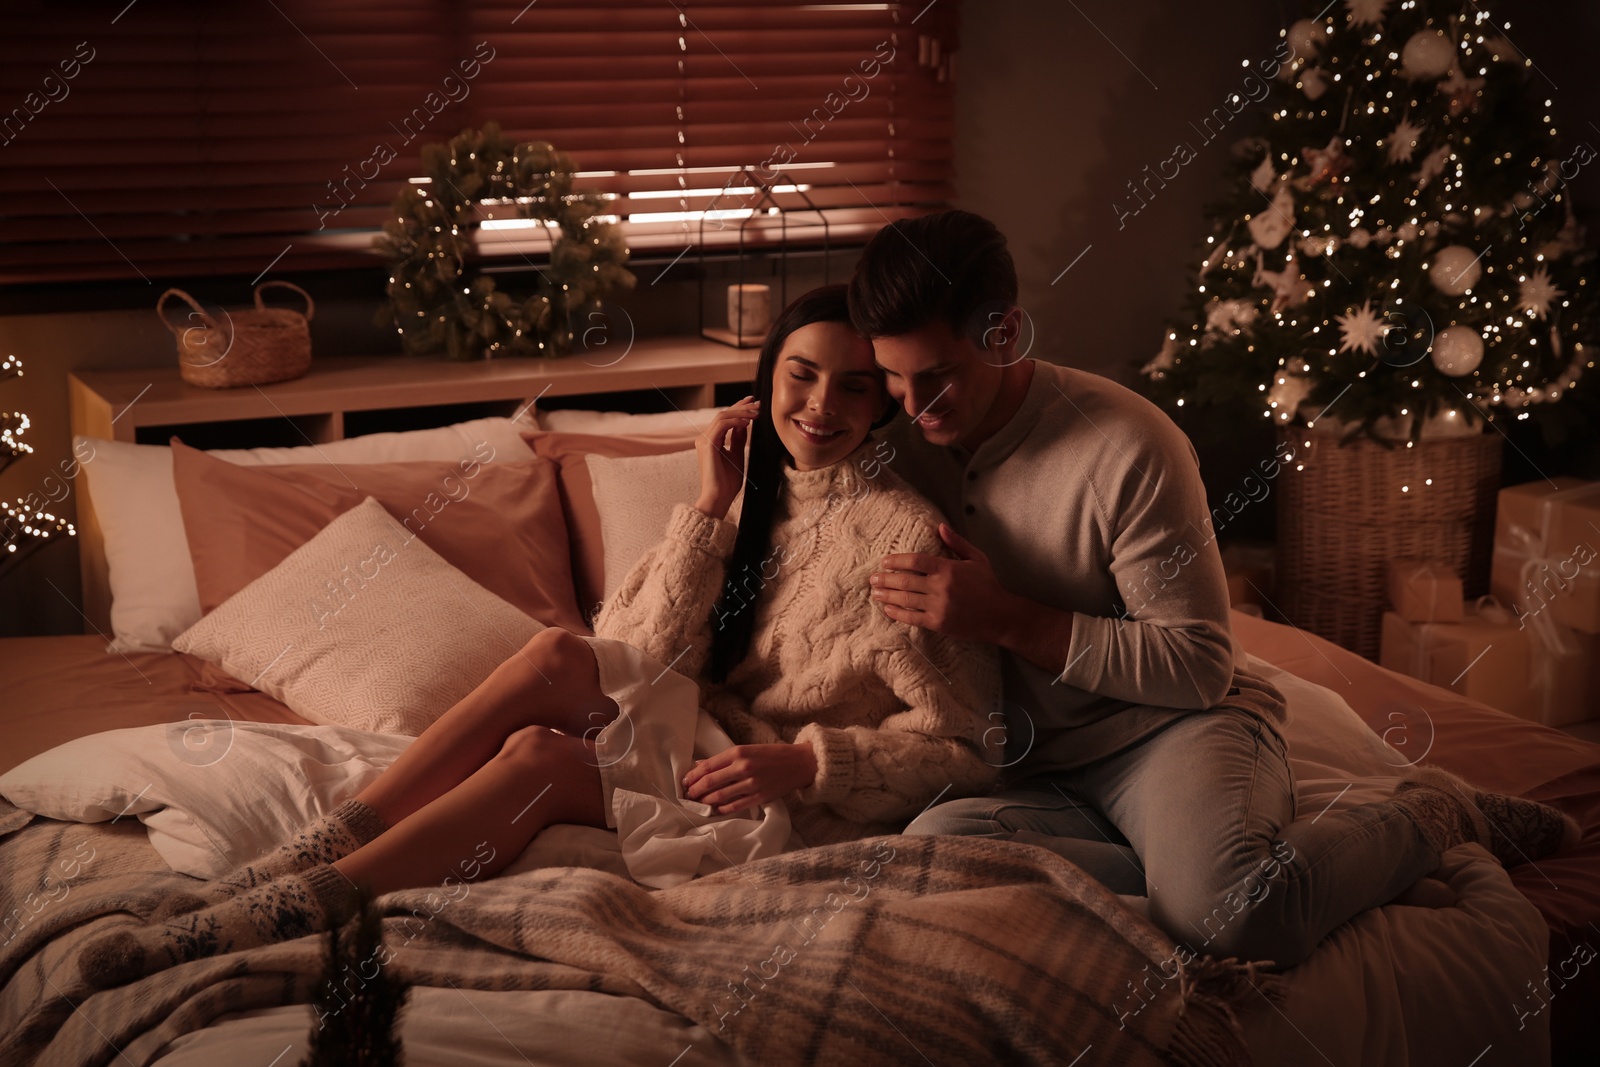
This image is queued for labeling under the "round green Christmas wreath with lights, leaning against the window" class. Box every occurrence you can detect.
[374,123,634,360]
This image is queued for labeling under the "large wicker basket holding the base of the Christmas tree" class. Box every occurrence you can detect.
[1277,426,1501,659]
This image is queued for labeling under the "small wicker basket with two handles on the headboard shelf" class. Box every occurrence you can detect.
[155,282,317,389]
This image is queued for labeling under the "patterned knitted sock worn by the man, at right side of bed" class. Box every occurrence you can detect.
[1394,766,1582,867]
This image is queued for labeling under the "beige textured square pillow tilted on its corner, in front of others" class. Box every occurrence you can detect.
[173,496,544,734]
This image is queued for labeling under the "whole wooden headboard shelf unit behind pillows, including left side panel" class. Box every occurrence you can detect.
[67,336,758,632]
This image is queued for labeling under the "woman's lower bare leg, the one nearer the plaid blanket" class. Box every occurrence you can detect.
[334,726,606,896]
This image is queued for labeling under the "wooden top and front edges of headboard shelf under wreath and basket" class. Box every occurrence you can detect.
[78,338,758,443]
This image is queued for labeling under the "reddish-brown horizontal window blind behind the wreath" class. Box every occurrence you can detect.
[0,0,957,283]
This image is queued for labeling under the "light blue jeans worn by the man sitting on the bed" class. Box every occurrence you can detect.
[906,709,1440,966]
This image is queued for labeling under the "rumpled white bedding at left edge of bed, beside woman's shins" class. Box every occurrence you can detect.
[0,718,413,878]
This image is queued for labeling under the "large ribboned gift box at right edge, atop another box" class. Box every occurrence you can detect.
[1490,478,1600,633]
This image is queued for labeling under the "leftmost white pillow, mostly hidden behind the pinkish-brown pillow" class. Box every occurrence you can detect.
[74,419,533,653]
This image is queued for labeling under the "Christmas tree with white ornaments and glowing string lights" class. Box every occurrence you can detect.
[1142,0,1600,442]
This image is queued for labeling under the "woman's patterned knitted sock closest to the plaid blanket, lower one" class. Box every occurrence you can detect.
[78,864,357,989]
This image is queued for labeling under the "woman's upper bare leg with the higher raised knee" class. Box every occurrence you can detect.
[357,627,618,843]
